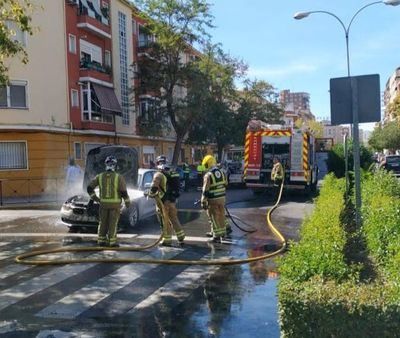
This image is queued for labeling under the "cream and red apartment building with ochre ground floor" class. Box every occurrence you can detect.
[0,0,203,203]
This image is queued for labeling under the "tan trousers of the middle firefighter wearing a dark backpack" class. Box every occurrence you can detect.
[156,199,185,243]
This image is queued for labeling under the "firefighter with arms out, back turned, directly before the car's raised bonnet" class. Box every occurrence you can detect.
[87,156,130,247]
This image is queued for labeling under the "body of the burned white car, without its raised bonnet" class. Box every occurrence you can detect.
[61,168,156,229]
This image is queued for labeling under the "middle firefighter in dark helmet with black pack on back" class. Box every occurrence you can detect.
[149,155,185,246]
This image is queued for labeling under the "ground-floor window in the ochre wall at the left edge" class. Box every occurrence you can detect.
[0,141,28,170]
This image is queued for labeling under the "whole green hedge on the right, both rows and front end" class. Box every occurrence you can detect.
[278,172,400,337]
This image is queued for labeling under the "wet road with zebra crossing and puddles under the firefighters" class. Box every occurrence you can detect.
[0,189,313,338]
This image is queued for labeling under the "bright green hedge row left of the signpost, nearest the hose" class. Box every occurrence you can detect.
[280,174,350,282]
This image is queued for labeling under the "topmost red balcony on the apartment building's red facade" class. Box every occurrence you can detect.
[77,6,111,39]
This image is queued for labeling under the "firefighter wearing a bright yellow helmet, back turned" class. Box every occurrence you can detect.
[201,155,227,243]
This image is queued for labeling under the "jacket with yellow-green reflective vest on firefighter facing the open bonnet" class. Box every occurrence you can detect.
[87,171,130,208]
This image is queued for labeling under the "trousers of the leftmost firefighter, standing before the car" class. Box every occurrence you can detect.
[97,205,120,245]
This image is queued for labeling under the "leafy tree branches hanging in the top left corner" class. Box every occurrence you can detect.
[0,0,34,86]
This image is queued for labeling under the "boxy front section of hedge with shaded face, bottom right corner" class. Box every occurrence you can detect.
[279,277,400,338]
